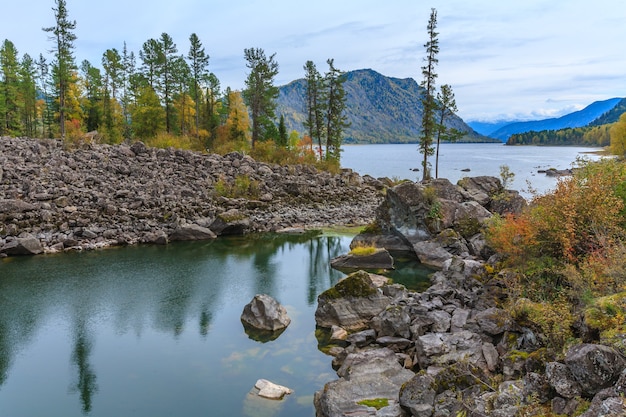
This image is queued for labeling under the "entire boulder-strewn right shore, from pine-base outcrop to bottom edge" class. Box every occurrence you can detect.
[315,177,626,417]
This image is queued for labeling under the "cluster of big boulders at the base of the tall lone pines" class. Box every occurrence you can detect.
[353,177,526,268]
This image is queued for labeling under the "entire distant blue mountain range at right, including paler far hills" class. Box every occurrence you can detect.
[468,98,626,142]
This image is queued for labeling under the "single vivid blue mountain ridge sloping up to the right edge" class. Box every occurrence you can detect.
[490,98,622,142]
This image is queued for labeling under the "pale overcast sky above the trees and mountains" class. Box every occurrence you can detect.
[0,0,626,121]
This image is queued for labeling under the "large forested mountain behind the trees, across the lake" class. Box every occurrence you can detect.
[276,69,493,143]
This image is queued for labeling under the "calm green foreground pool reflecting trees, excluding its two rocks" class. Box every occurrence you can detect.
[0,235,428,417]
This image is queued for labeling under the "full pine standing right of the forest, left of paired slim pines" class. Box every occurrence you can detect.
[243,48,278,148]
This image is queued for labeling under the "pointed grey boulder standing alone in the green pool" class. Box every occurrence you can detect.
[241,294,291,332]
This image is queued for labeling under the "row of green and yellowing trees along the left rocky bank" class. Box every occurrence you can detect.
[0,0,347,163]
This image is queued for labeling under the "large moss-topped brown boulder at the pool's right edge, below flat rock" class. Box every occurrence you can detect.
[315,271,392,332]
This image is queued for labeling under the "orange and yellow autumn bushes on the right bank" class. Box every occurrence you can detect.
[488,160,626,298]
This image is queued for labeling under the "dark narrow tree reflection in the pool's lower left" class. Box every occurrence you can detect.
[70,317,98,414]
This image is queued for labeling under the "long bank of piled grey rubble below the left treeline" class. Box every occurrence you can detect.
[0,137,383,256]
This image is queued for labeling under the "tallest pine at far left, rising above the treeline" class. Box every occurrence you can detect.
[43,0,76,139]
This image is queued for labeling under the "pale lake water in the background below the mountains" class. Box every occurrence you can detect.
[341,143,600,196]
